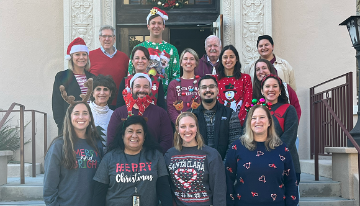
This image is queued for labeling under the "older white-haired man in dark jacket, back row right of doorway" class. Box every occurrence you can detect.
[195,35,221,77]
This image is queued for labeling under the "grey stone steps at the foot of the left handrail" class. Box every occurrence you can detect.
[0,174,44,201]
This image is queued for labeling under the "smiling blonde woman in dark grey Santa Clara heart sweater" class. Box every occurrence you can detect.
[165,112,226,206]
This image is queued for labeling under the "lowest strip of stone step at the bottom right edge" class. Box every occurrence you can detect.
[299,197,356,206]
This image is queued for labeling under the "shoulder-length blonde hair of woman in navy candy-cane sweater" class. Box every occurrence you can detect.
[240,104,282,151]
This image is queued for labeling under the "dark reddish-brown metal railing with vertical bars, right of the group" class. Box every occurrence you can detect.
[310,72,354,180]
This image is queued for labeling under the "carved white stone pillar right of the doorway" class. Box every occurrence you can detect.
[221,0,272,66]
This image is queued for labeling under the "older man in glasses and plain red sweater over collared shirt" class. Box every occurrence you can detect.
[89,25,129,110]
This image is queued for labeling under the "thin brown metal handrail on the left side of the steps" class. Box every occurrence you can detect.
[0,102,47,184]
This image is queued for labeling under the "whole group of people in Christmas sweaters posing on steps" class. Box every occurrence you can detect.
[44,7,301,206]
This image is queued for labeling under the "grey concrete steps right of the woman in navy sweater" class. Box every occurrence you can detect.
[299,173,356,206]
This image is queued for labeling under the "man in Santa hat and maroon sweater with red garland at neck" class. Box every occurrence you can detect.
[107,73,174,153]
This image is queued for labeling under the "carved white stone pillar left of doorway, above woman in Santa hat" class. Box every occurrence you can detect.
[63,0,116,69]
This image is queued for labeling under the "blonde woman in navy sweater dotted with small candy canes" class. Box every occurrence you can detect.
[225,104,299,206]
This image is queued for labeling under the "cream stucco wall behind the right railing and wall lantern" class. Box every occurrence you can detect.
[272,0,356,159]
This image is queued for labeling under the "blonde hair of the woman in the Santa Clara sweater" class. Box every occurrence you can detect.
[174,112,204,151]
